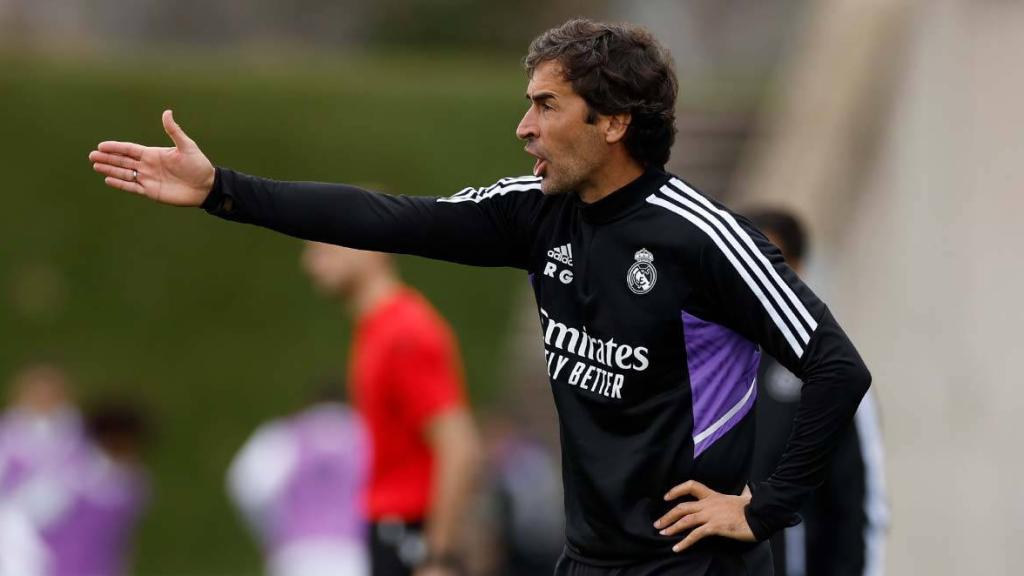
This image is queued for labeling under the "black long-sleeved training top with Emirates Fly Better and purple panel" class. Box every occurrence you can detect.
[203,163,870,565]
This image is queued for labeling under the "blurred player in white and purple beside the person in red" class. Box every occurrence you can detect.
[227,385,370,576]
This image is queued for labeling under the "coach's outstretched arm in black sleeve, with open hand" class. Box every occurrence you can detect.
[89,111,546,268]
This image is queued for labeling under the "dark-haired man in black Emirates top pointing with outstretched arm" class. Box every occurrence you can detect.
[90,19,870,575]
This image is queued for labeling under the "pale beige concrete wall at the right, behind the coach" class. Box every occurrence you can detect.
[742,0,1024,575]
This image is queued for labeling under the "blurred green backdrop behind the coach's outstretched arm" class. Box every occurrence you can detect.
[0,51,531,576]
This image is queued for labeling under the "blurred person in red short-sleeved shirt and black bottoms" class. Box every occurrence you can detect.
[302,242,480,576]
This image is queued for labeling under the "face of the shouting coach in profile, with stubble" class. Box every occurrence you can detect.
[516,60,609,194]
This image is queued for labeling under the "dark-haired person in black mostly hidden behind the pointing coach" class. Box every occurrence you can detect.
[748,210,888,576]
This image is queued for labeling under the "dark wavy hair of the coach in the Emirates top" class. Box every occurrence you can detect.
[523,18,679,167]
